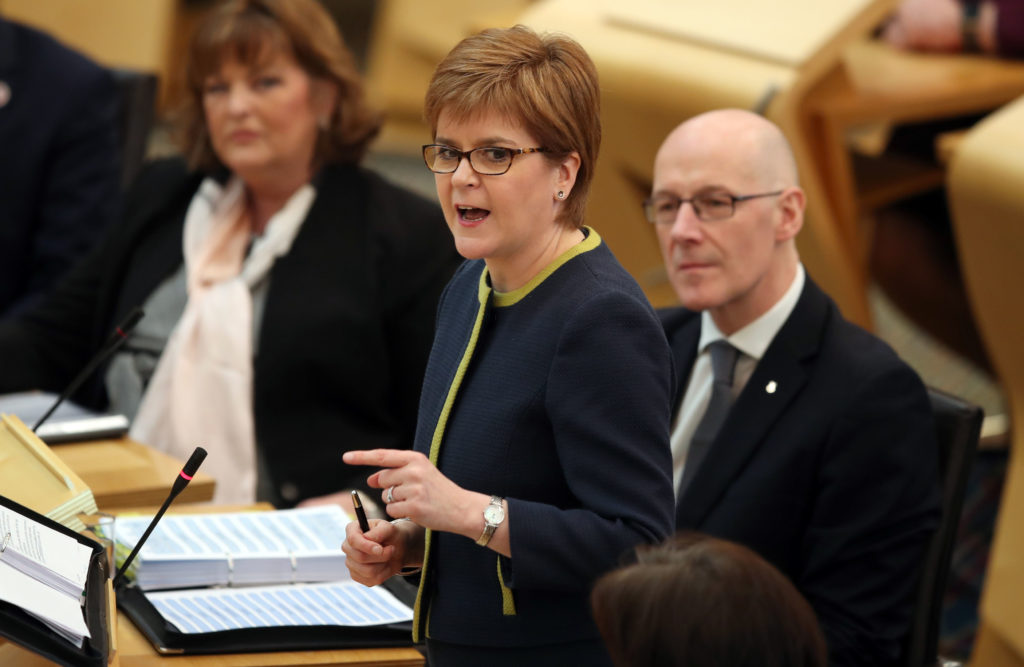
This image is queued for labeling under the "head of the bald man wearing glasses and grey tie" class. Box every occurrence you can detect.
[650,109,804,334]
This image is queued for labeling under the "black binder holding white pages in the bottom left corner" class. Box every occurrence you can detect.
[0,496,111,667]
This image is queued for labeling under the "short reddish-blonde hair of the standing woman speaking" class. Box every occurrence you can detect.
[424,26,601,226]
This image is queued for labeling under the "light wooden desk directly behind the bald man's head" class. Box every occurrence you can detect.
[521,0,893,326]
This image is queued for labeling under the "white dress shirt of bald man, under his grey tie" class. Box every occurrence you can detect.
[672,264,806,493]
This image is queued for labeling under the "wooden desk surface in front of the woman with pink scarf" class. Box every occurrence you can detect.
[52,437,214,510]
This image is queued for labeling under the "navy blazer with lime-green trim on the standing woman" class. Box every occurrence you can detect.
[416,233,673,665]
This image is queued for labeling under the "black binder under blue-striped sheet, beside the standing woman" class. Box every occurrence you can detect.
[117,577,416,655]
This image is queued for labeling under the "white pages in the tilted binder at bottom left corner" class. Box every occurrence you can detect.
[0,506,91,648]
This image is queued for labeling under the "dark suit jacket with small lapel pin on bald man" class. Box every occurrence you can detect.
[660,278,939,665]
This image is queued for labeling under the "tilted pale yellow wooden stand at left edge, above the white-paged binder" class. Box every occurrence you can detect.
[0,415,97,532]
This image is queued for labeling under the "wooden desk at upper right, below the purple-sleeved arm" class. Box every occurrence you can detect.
[801,40,1024,265]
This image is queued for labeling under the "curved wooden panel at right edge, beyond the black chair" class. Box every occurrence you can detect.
[948,97,1024,665]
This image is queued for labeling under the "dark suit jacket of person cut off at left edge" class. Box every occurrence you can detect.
[0,18,121,319]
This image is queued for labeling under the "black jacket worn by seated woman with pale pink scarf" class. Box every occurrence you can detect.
[0,160,460,505]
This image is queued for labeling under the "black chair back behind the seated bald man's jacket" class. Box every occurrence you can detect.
[904,388,983,667]
